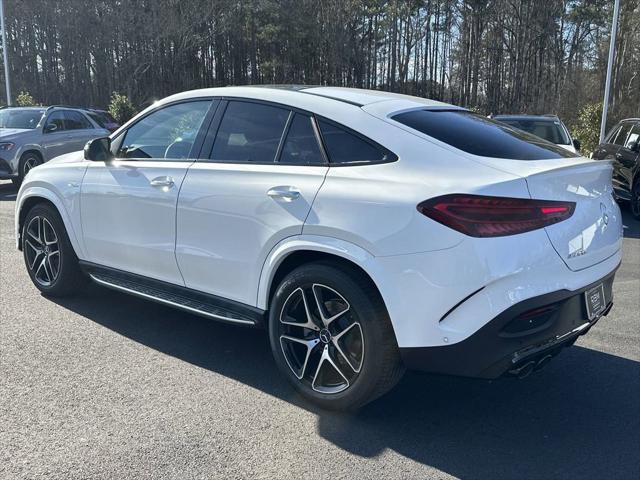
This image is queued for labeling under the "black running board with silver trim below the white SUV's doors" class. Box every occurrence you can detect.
[81,262,264,326]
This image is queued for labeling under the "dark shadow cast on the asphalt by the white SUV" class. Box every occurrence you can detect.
[50,285,640,479]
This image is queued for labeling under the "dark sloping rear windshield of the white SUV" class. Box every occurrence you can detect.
[392,109,577,160]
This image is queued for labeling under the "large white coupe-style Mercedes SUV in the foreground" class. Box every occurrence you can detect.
[15,87,622,408]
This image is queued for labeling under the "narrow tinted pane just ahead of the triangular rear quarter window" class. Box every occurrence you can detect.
[280,113,324,165]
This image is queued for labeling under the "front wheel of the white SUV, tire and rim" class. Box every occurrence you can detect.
[21,203,86,297]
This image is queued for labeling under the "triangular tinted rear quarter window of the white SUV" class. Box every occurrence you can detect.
[318,120,395,164]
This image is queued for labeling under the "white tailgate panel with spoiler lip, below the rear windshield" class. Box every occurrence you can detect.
[482,158,622,271]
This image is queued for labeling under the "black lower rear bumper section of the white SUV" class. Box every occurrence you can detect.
[400,268,617,378]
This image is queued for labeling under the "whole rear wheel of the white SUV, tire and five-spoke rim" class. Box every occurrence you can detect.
[269,262,404,410]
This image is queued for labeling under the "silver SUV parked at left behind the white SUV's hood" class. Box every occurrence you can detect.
[0,106,110,185]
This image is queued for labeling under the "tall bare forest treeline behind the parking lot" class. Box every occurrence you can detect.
[5,0,640,128]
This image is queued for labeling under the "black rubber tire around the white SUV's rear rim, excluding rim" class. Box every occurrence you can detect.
[269,263,395,410]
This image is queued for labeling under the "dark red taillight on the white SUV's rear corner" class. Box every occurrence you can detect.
[418,194,576,237]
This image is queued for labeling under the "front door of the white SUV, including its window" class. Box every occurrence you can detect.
[81,99,214,285]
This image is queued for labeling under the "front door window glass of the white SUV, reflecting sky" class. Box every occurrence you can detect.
[117,100,211,159]
